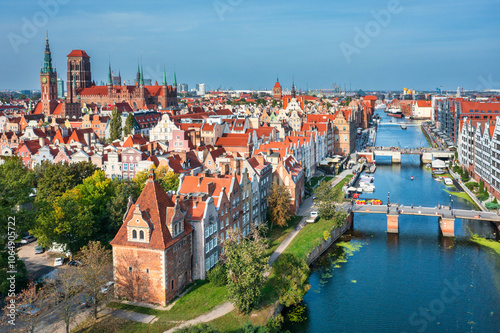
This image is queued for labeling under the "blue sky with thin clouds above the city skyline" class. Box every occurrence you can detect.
[0,0,500,91]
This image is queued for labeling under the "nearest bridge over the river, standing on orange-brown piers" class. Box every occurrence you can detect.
[343,203,500,237]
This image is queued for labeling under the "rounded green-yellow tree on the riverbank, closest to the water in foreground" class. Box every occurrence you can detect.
[273,253,311,307]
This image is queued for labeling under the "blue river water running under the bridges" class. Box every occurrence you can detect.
[286,112,500,332]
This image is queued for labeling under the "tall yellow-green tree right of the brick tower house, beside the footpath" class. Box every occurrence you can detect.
[223,228,268,313]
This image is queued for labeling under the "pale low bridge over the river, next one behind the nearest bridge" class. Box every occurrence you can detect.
[358,147,455,163]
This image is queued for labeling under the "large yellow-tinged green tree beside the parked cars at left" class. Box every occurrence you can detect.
[33,188,94,253]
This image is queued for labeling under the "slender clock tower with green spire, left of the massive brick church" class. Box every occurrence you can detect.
[40,33,57,116]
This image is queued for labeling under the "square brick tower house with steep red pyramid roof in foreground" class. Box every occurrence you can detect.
[110,172,193,305]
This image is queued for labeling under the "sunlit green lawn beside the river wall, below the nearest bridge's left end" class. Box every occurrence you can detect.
[285,218,333,259]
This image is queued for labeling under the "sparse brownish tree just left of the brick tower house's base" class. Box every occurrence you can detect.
[79,242,113,319]
